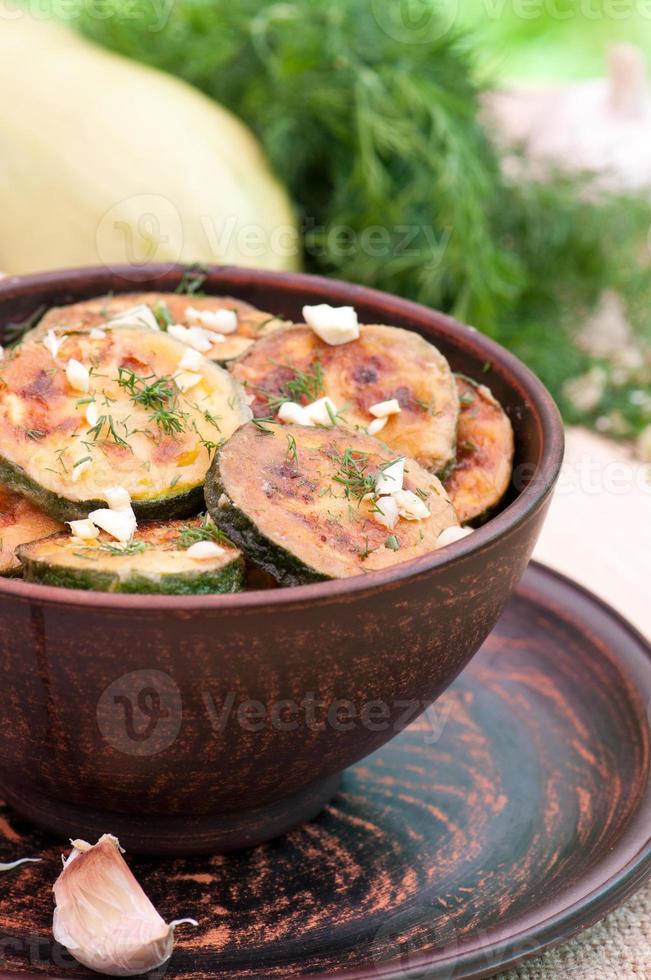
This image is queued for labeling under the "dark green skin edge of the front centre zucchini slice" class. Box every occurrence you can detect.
[205,453,332,586]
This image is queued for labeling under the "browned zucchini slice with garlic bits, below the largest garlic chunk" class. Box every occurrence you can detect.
[232,325,459,473]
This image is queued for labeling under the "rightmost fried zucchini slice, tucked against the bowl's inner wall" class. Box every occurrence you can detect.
[445,375,513,524]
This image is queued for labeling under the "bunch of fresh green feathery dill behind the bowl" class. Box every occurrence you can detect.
[78,0,651,431]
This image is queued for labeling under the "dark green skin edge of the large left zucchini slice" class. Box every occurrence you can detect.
[0,456,203,522]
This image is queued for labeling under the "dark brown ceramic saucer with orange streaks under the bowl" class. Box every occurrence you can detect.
[0,565,651,980]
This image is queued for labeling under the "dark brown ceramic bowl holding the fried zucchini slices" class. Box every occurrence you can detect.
[0,266,563,854]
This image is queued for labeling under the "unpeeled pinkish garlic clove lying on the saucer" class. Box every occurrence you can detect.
[52,834,197,977]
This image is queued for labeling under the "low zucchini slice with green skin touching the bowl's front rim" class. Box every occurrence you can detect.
[18,517,245,595]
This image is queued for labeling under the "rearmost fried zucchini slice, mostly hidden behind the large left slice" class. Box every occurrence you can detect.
[29,293,283,364]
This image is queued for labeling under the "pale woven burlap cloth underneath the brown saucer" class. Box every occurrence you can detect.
[499,429,651,980]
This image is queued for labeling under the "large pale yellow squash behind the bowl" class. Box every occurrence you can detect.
[0,9,298,273]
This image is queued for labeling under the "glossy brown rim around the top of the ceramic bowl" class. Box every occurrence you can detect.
[0,263,564,613]
